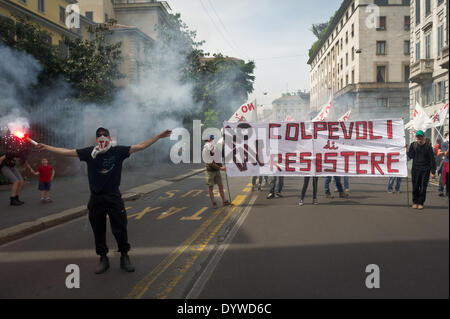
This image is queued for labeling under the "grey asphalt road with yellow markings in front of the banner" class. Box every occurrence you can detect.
[0,174,449,298]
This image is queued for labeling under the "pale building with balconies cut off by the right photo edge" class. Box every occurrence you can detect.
[410,0,449,141]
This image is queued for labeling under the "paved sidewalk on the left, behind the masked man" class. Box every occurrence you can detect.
[0,164,204,231]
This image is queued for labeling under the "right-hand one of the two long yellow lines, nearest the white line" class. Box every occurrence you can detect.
[156,195,247,299]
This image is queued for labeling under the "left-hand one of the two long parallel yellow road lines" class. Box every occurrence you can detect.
[126,207,229,299]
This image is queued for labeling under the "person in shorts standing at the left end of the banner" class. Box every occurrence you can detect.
[203,135,231,208]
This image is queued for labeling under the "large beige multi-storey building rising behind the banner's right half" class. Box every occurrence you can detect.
[308,0,410,121]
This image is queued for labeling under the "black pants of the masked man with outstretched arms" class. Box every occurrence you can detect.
[88,192,130,256]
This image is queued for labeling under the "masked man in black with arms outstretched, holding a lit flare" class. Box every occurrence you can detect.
[37,127,172,274]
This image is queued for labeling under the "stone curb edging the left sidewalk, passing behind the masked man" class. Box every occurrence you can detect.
[0,168,205,246]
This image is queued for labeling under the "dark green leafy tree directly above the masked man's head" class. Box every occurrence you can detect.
[63,19,124,104]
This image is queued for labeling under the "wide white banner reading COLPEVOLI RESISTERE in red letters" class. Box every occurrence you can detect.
[224,119,407,177]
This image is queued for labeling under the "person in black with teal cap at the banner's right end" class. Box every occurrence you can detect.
[407,130,436,210]
